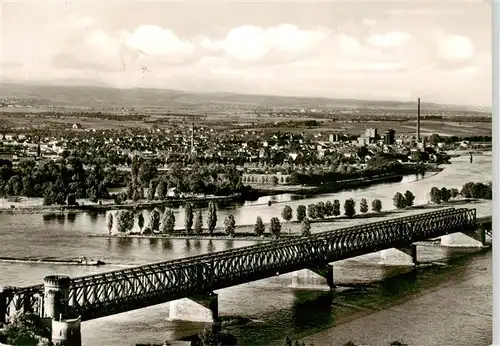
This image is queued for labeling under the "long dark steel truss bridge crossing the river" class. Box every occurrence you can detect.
[0,208,491,335]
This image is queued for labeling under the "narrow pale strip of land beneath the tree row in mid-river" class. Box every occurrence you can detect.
[88,198,491,241]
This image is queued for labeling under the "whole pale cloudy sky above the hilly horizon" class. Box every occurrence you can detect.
[0,0,492,106]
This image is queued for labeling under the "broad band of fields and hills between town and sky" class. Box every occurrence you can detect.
[0,83,491,136]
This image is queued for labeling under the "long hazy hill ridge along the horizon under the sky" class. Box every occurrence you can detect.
[0,82,491,113]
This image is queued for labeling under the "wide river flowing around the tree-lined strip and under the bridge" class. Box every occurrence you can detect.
[0,156,492,346]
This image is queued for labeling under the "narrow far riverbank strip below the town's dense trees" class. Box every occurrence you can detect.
[0,168,422,214]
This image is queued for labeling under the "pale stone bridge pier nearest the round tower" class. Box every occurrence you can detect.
[168,292,219,323]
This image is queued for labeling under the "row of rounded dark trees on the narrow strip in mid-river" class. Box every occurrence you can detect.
[103,182,492,238]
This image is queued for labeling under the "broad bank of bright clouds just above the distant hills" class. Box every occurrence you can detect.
[1,11,490,105]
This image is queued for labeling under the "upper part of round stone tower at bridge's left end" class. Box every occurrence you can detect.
[42,275,70,320]
